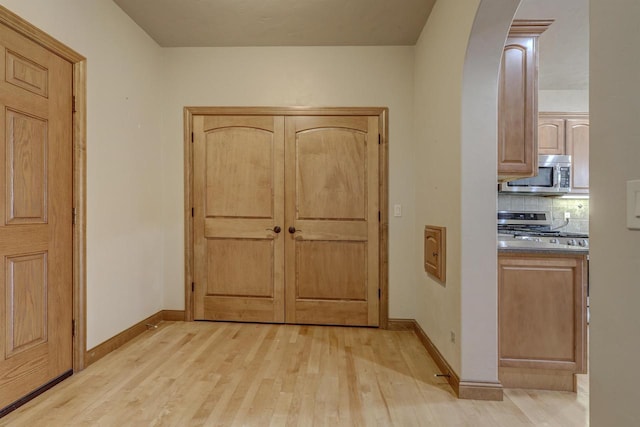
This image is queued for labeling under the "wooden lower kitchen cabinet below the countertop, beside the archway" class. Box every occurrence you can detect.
[498,252,587,391]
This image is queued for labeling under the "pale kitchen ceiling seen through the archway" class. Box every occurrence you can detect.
[516,0,589,90]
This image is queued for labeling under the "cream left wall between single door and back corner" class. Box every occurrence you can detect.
[0,0,163,348]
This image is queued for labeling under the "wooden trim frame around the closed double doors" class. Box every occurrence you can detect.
[184,107,389,329]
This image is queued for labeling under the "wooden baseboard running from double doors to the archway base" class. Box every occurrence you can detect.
[389,319,503,401]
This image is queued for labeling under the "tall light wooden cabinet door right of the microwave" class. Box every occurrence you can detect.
[567,119,589,193]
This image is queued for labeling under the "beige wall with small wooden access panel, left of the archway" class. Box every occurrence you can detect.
[413,0,478,374]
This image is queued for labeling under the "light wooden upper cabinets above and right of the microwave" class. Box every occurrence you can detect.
[538,112,589,194]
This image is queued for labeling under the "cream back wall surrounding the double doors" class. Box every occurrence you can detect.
[162,47,418,318]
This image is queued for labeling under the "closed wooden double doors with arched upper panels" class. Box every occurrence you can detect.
[192,115,379,326]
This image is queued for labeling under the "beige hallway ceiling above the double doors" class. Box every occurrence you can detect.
[114,0,435,47]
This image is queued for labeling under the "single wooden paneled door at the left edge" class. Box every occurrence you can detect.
[0,25,73,408]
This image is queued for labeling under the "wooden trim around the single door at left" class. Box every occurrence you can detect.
[0,6,87,372]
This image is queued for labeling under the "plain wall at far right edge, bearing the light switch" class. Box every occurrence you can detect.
[590,0,640,427]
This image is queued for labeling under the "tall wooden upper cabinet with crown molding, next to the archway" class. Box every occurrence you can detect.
[498,20,553,181]
